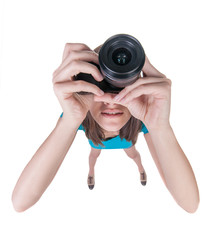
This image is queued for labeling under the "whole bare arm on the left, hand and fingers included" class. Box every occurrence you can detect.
[12,43,104,212]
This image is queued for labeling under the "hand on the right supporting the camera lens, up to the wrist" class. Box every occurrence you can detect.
[95,56,171,129]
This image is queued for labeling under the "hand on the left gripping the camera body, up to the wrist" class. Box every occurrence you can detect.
[52,43,104,123]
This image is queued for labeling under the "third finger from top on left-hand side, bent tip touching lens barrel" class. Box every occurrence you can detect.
[52,60,104,83]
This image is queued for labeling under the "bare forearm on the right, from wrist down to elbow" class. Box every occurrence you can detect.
[149,125,199,212]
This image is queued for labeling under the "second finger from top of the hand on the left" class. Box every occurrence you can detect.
[53,50,99,77]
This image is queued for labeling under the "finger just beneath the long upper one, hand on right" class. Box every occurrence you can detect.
[116,82,169,104]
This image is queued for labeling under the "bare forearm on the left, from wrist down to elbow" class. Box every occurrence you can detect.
[12,117,79,211]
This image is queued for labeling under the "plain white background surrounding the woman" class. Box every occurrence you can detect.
[0,0,218,240]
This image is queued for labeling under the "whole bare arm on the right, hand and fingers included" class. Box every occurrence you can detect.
[107,52,199,212]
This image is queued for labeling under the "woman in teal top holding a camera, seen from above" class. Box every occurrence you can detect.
[12,43,199,212]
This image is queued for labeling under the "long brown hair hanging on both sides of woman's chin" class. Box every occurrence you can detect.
[82,111,142,147]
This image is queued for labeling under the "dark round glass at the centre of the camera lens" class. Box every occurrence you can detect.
[112,48,132,65]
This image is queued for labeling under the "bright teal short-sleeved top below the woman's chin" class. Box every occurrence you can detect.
[60,113,148,149]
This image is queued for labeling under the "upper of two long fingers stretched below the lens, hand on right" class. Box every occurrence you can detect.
[114,77,171,101]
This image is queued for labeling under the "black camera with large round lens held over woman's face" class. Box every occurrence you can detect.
[75,34,146,93]
